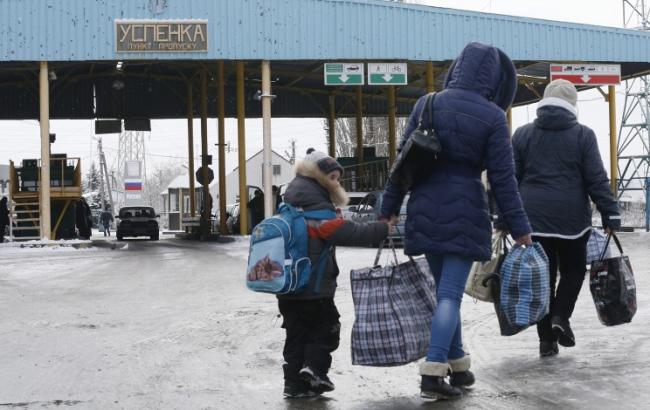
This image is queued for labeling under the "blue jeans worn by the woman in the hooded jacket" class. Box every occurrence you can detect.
[426,253,473,363]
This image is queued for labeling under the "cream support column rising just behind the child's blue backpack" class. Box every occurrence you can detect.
[261,60,275,218]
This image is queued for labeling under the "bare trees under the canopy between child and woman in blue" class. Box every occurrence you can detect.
[325,117,408,157]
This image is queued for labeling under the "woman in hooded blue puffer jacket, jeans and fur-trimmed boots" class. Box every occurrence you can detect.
[381,43,531,398]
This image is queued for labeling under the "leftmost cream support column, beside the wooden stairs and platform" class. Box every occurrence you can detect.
[38,61,52,239]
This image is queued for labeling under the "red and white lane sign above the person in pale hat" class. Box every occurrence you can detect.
[550,64,621,85]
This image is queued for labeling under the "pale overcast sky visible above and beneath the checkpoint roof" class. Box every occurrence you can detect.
[0,0,636,186]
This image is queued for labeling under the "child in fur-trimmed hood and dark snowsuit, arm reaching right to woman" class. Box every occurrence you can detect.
[278,150,389,397]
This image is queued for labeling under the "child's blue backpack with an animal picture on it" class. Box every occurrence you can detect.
[246,203,336,295]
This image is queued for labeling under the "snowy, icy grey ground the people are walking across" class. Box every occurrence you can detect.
[0,233,650,410]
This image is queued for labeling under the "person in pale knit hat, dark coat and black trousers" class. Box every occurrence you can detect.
[512,80,621,357]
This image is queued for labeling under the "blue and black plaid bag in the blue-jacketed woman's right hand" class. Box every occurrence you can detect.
[493,243,551,336]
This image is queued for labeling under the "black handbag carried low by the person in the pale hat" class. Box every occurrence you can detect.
[589,233,637,326]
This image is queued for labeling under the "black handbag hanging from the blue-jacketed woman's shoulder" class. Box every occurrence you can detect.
[389,93,442,191]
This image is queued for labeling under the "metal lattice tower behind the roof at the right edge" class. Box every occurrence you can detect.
[617,0,650,229]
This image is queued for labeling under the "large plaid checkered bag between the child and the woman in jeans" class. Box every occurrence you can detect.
[350,240,436,366]
